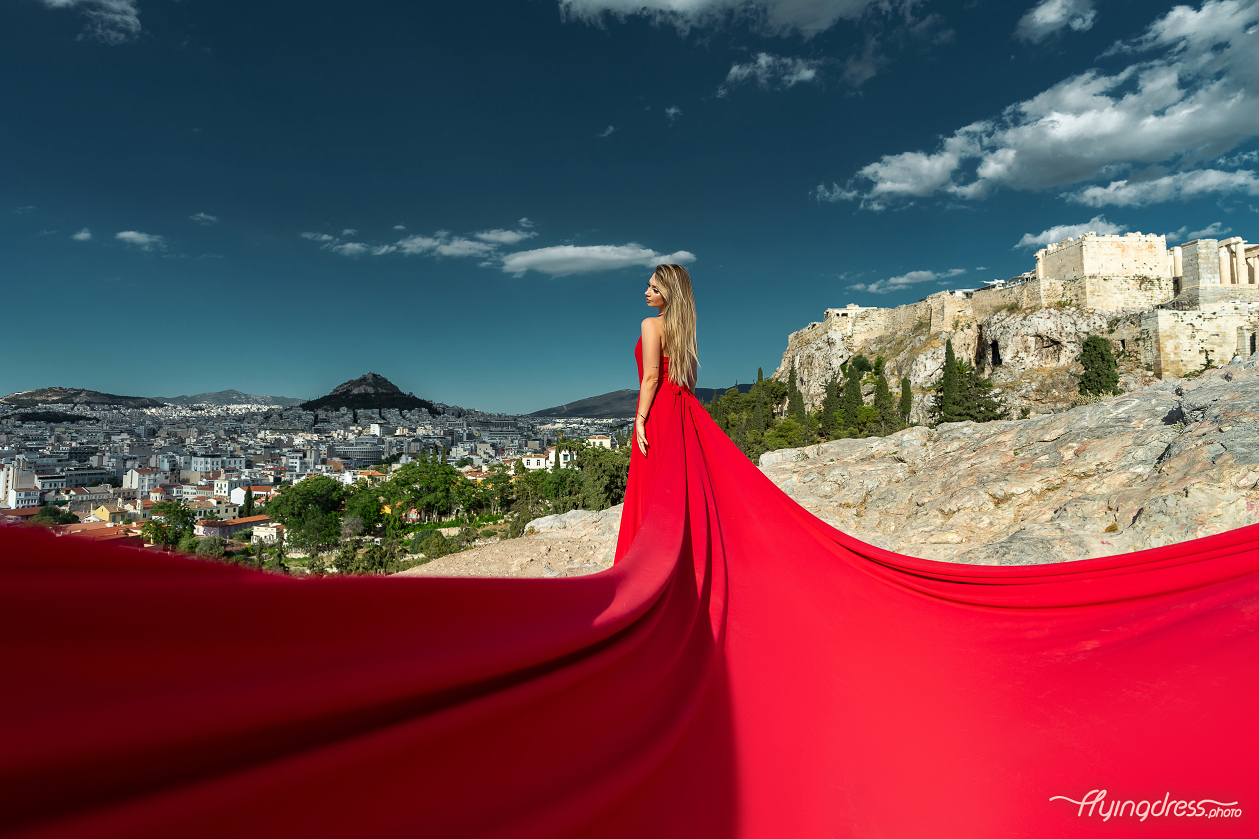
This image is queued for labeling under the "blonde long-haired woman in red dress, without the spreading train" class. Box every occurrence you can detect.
[616,265,699,561]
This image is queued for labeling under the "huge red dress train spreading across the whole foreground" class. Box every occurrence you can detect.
[0,342,1259,839]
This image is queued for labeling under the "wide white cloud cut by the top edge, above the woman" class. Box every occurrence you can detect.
[559,0,891,38]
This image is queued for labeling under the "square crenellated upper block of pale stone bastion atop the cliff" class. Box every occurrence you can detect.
[1036,233,1172,280]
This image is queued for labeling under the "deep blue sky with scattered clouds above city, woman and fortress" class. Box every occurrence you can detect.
[0,0,1259,412]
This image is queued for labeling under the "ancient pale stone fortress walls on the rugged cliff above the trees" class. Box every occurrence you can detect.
[774,226,1259,420]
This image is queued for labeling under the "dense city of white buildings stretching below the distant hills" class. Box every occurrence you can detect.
[0,374,630,545]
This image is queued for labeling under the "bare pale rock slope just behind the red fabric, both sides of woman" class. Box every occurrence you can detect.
[410,355,1259,576]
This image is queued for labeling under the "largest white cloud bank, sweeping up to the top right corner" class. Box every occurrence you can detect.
[813,0,1259,210]
